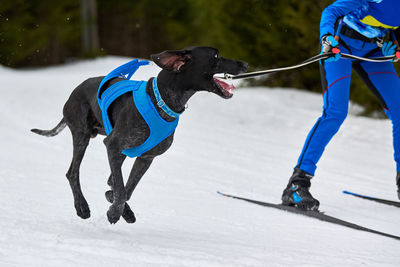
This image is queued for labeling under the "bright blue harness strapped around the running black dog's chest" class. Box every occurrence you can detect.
[97,59,180,158]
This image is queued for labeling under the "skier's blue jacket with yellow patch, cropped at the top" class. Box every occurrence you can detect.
[320,0,400,38]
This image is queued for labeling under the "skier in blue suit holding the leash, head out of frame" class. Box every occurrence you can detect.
[282,0,400,210]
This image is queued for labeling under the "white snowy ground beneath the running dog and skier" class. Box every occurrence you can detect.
[0,57,400,267]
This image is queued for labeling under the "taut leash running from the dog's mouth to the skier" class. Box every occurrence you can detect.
[219,52,396,80]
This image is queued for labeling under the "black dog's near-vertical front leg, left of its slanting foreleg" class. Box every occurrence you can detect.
[104,137,127,223]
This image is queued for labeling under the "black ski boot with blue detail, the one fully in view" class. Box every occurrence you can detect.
[282,168,319,211]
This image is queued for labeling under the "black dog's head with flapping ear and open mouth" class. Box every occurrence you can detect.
[151,46,248,98]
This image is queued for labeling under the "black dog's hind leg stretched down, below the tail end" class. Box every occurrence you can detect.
[66,131,90,219]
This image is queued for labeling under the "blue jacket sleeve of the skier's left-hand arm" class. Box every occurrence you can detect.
[320,0,368,39]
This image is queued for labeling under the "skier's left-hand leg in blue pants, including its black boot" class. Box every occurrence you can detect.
[282,59,352,210]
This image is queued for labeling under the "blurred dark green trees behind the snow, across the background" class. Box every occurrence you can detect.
[0,0,392,114]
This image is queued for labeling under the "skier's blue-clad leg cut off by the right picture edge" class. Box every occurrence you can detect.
[354,57,400,198]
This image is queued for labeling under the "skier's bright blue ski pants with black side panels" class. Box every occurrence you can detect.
[296,33,400,175]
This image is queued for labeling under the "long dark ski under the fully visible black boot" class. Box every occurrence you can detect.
[217,191,400,240]
